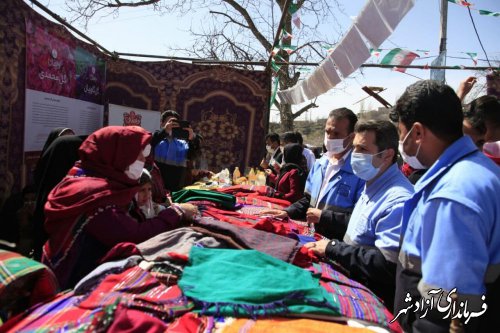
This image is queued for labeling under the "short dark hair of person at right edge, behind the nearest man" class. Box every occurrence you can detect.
[464,95,500,134]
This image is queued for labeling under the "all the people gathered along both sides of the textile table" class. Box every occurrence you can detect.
[1,79,500,332]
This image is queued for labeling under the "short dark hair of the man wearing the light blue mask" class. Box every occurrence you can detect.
[354,120,399,163]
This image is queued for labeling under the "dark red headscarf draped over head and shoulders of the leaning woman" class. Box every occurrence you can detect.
[45,126,151,257]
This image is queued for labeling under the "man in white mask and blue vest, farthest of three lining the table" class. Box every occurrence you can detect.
[261,108,365,239]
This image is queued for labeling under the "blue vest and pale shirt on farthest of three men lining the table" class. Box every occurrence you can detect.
[305,153,365,209]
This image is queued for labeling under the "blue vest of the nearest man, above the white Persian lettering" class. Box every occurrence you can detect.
[399,136,500,305]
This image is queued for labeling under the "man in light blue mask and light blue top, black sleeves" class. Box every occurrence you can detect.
[305,120,413,310]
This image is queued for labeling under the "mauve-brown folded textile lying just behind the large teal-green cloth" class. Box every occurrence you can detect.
[192,217,300,262]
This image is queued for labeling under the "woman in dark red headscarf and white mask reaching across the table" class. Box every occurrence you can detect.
[42,126,196,288]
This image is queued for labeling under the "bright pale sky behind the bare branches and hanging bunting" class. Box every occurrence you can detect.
[30,0,500,122]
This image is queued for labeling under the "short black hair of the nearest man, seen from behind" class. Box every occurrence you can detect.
[389,80,463,142]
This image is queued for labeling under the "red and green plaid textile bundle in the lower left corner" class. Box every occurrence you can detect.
[0,250,59,312]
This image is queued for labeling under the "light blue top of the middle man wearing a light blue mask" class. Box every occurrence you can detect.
[344,163,413,263]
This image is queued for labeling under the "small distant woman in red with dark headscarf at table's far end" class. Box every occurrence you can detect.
[266,143,306,202]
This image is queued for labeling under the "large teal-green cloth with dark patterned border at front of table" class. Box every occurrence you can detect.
[178,247,340,317]
